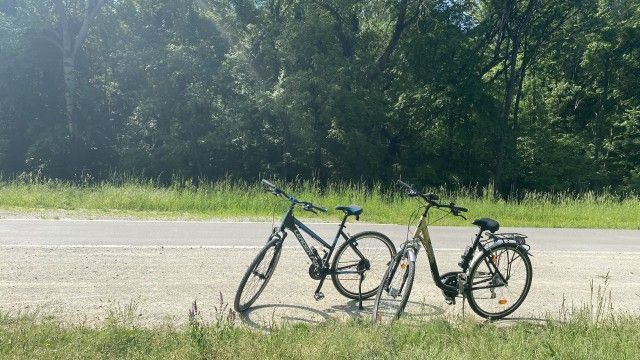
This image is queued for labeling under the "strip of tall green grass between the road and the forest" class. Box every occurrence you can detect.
[0,179,640,229]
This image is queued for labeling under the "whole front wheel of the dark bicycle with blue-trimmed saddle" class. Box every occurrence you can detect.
[233,236,282,312]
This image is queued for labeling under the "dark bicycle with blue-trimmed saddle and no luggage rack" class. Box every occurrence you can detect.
[234,180,396,312]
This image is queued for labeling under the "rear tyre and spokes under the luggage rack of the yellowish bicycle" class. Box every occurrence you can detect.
[466,243,533,320]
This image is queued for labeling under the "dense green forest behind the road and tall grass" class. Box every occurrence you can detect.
[0,0,640,194]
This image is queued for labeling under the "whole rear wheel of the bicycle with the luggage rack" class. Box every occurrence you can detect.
[467,244,532,320]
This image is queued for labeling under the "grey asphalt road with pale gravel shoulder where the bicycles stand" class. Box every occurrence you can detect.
[0,219,640,327]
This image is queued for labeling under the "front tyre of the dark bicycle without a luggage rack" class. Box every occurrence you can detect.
[233,236,282,312]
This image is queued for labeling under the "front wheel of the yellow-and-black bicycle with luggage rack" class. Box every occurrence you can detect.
[372,250,416,323]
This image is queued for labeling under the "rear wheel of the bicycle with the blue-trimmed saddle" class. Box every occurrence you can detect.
[331,231,396,300]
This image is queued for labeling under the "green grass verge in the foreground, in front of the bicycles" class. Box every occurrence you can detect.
[0,315,640,360]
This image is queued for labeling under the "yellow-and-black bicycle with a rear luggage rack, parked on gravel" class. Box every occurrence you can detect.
[373,181,532,322]
